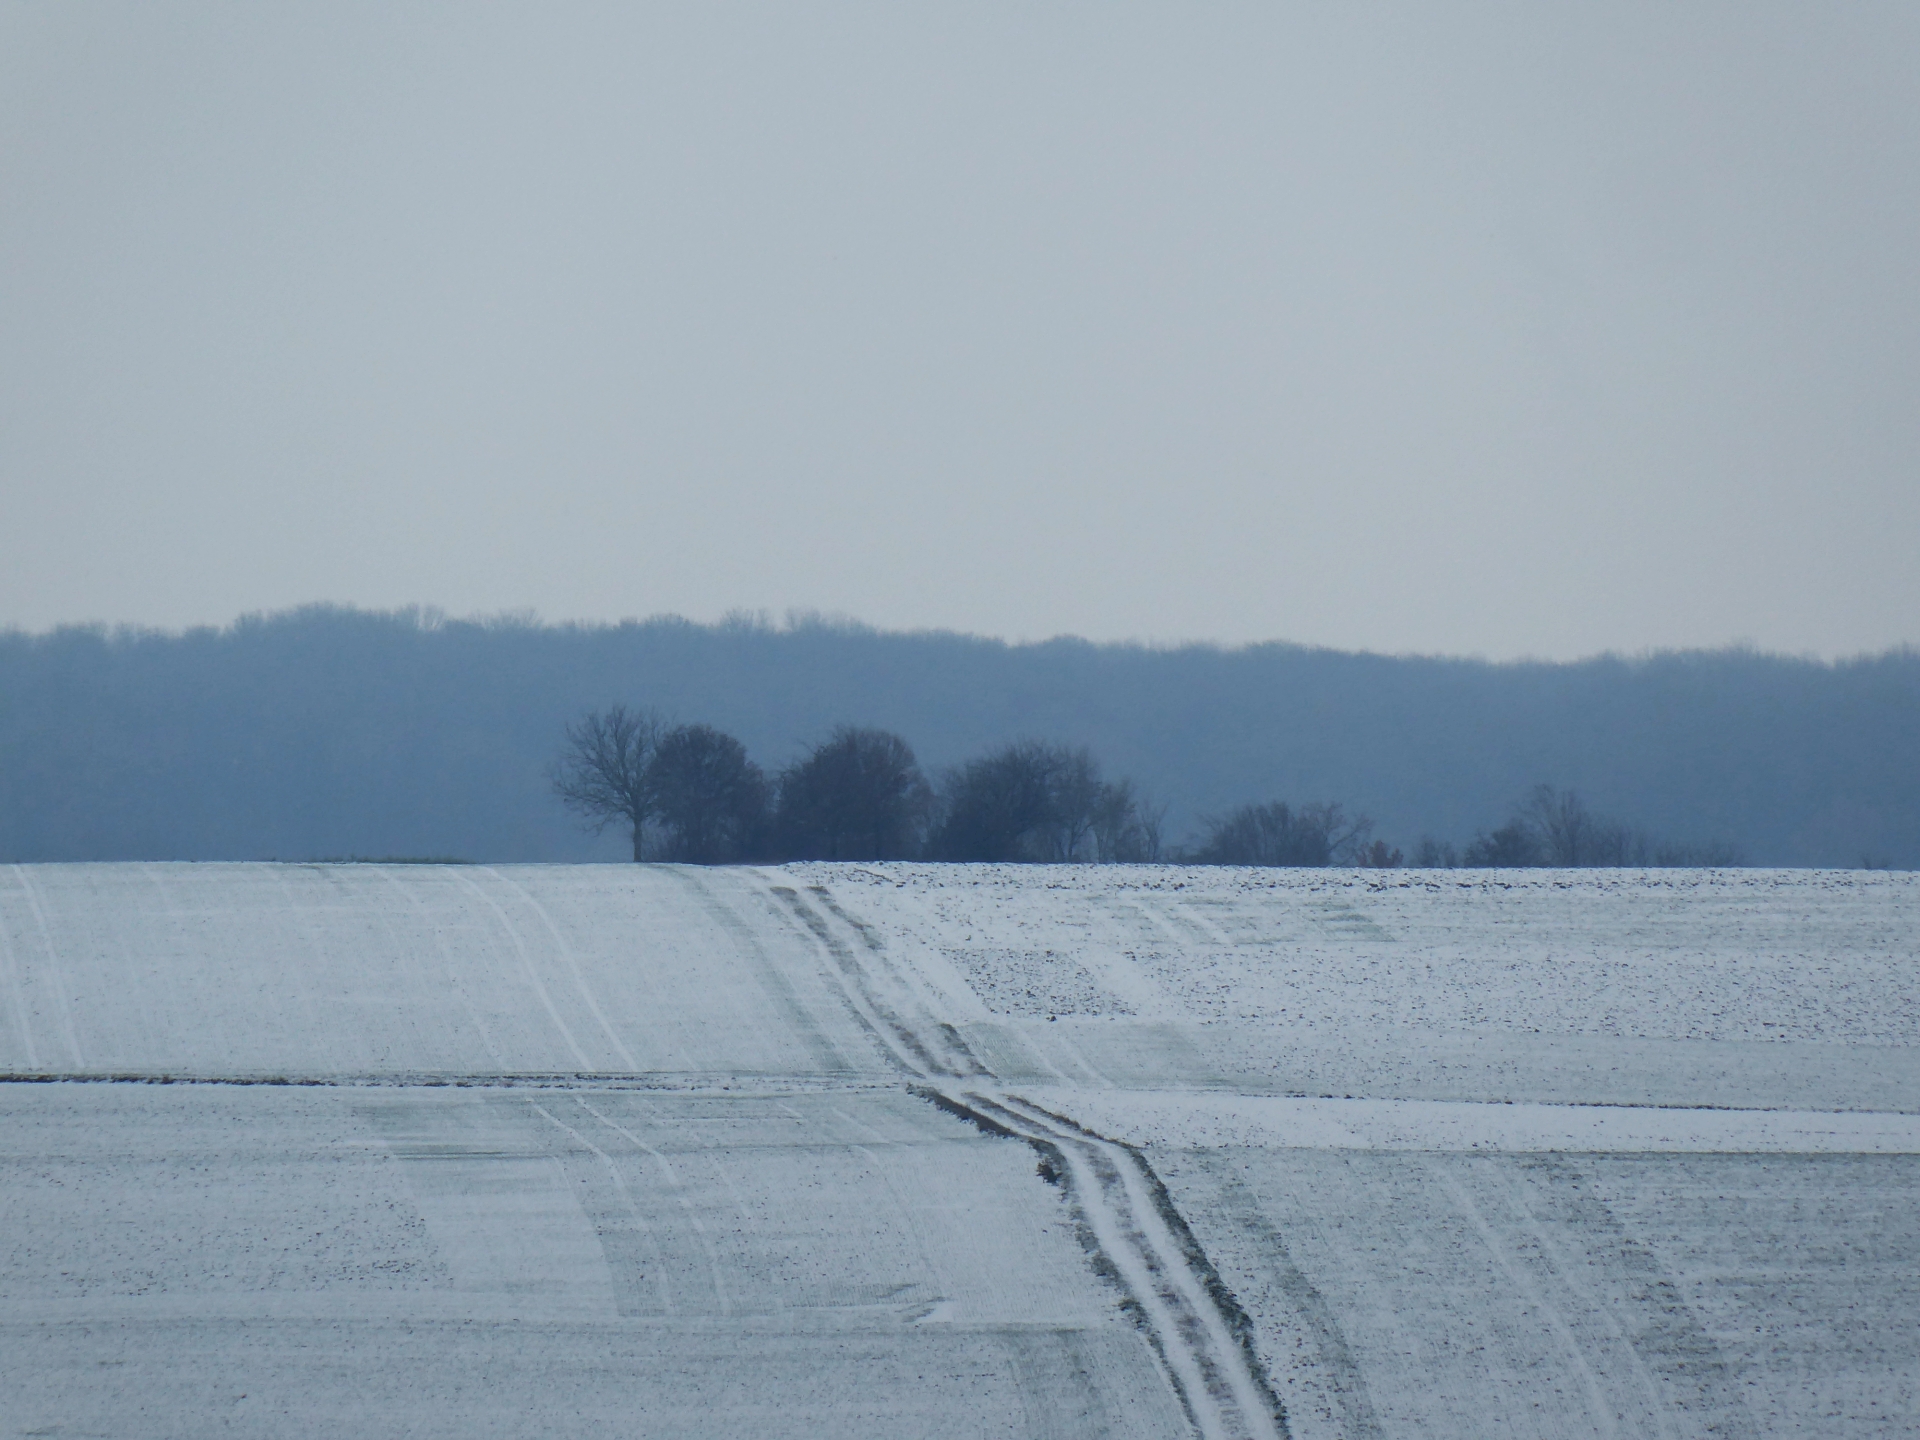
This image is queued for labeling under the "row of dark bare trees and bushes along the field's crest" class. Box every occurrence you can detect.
[551,705,1740,870]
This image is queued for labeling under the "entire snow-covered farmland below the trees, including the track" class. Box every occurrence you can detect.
[0,864,1920,1440]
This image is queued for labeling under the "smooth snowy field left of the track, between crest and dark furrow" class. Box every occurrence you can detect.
[0,864,887,1075]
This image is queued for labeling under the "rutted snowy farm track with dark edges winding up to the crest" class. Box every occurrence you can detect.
[768,883,1288,1440]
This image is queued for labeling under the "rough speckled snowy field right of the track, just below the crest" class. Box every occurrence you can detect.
[818,866,1920,1046]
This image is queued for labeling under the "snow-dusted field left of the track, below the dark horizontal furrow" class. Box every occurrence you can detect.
[0,1083,1181,1436]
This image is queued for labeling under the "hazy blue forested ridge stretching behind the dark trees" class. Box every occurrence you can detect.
[11,607,1920,868]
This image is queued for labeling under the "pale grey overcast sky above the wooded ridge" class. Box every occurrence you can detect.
[0,0,1920,657]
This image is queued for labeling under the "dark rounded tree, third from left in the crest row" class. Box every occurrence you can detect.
[774,726,933,860]
